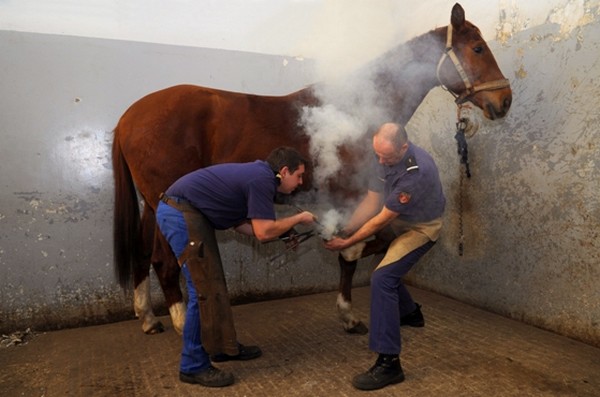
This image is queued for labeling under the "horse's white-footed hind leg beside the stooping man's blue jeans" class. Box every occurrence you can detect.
[152,227,186,335]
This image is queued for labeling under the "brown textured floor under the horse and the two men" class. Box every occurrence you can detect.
[0,287,600,397]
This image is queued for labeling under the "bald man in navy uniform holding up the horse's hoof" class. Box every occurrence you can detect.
[325,123,446,390]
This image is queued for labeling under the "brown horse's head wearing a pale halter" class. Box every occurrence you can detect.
[437,3,512,120]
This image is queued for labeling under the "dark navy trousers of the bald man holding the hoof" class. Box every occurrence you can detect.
[369,241,435,354]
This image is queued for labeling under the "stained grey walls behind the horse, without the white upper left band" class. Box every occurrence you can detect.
[0,0,600,345]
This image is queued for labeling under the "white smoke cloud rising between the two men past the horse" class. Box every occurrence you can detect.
[290,0,450,234]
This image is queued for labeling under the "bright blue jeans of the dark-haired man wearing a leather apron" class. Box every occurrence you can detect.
[156,201,210,374]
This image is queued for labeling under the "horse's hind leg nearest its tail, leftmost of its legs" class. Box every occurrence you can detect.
[133,205,165,335]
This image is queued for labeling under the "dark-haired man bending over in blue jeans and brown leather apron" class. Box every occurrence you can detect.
[156,147,315,387]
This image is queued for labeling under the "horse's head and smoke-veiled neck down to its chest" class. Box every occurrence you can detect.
[303,3,512,203]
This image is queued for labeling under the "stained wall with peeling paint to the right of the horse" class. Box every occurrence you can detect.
[409,3,600,345]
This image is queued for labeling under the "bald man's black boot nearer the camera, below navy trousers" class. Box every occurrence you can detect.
[352,354,404,390]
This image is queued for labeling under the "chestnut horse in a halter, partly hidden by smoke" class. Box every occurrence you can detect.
[112,4,512,333]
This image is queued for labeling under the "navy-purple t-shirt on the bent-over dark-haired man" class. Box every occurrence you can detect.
[165,160,277,230]
